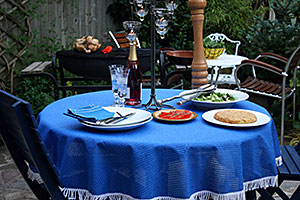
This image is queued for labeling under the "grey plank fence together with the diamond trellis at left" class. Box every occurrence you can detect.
[0,0,118,90]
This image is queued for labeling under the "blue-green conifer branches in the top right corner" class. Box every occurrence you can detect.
[244,0,300,58]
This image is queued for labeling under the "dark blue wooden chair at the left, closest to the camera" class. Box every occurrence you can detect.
[0,90,66,200]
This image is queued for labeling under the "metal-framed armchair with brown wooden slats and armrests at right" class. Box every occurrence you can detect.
[235,45,300,144]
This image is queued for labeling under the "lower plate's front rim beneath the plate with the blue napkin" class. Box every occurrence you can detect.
[79,116,153,131]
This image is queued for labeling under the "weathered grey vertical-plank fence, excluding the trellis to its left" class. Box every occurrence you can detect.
[31,0,117,47]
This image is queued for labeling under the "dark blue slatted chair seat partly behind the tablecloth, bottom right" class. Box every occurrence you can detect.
[257,142,300,200]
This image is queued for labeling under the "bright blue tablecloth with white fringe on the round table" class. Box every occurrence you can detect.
[38,89,281,200]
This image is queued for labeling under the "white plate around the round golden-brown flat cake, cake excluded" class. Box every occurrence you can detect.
[202,109,271,127]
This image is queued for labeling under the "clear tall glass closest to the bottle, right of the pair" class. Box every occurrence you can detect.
[117,68,130,108]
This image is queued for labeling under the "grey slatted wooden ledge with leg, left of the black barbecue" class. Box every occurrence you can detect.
[21,61,59,100]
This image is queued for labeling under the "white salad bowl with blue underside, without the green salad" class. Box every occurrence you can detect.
[180,89,249,110]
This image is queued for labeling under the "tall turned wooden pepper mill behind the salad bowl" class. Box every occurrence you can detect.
[188,0,208,88]
